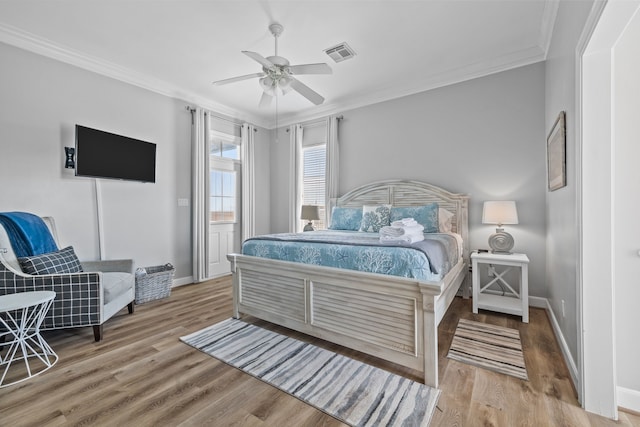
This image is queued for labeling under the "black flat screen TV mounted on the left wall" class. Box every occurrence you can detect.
[76,125,156,182]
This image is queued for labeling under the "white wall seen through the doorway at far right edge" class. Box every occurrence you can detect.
[613,10,640,411]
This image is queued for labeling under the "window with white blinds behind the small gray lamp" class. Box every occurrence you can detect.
[302,144,327,230]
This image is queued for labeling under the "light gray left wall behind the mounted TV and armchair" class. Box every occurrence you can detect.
[0,44,191,279]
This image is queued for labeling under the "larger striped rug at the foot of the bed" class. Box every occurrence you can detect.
[180,319,440,426]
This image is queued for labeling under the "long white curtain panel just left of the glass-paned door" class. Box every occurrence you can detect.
[191,108,209,283]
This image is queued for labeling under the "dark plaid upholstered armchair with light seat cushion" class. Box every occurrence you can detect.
[0,217,135,341]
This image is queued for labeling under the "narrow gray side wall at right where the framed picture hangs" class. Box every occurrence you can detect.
[545,1,593,380]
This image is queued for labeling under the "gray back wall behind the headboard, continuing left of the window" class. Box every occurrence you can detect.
[271,63,546,297]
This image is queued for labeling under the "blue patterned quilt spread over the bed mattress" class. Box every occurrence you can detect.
[242,230,459,281]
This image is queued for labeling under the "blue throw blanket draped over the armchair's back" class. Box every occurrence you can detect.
[0,212,58,257]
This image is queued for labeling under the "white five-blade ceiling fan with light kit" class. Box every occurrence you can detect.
[213,23,332,107]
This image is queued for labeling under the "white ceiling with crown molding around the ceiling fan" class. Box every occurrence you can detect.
[0,0,558,128]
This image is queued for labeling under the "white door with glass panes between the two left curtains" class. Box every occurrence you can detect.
[208,155,242,277]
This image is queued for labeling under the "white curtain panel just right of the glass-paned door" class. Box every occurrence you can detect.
[240,123,256,242]
